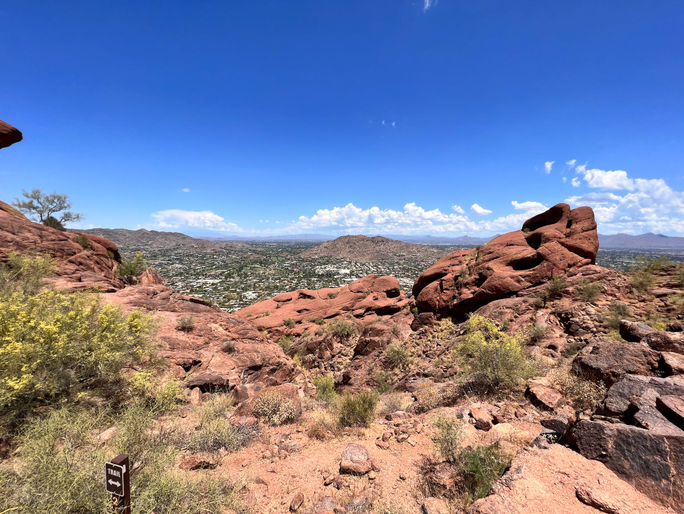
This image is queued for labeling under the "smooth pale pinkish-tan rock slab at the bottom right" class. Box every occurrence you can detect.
[467,444,674,514]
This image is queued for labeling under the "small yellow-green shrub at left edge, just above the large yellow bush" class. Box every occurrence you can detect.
[0,253,56,295]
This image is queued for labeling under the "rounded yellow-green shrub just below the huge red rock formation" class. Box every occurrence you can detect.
[455,314,537,388]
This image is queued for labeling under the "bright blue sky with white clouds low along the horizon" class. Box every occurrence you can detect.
[0,0,684,236]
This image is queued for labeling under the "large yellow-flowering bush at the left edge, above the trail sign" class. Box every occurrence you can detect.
[0,290,153,428]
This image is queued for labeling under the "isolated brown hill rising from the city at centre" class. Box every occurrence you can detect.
[299,235,448,262]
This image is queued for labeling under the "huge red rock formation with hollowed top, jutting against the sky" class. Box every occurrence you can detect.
[413,203,598,317]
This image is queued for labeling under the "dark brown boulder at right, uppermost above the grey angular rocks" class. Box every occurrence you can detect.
[572,340,659,387]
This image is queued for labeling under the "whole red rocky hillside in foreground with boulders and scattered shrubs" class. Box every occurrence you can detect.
[0,175,684,508]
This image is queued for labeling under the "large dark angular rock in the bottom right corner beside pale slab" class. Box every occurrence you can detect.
[570,420,684,510]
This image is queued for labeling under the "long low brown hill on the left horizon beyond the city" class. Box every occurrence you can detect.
[79,228,245,251]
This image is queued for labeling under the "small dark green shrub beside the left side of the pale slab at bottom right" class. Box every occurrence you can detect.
[454,443,510,504]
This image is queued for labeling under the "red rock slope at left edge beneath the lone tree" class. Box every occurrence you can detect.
[0,198,125,291]
